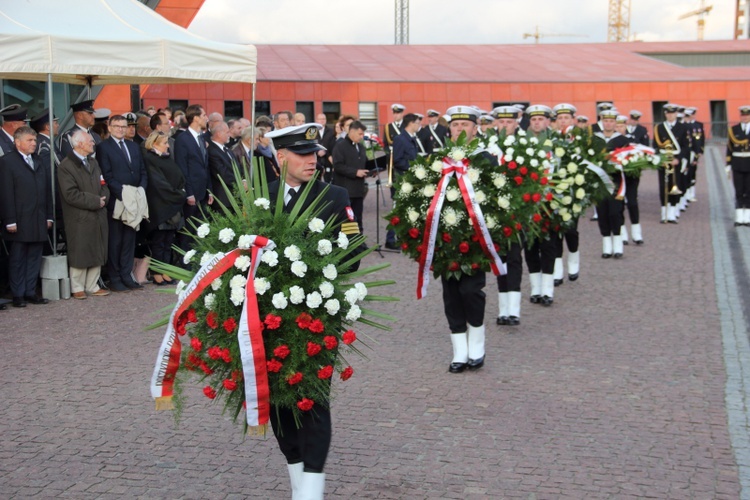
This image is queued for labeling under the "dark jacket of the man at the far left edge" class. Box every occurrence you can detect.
[0,150,52,242]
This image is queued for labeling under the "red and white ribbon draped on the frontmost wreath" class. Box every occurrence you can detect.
[151,236,276,426]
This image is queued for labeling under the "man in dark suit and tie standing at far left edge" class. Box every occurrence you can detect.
[0,125,53,307]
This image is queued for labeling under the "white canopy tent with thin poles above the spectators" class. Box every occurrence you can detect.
[0,0,257,260]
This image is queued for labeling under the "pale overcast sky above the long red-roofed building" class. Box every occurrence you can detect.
[189,0,735,44]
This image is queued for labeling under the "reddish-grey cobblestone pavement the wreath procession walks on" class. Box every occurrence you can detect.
[0,146,750,499]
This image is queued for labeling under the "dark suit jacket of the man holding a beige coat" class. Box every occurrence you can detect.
[96,137,148,212]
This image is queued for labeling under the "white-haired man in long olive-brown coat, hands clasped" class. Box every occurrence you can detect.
[57,130,109,300]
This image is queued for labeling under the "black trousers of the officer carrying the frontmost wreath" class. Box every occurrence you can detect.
[271,405,332,472]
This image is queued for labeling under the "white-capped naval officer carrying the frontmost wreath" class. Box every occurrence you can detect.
[267,123,359,500]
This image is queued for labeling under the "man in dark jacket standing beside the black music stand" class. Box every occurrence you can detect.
[333,120,370,232]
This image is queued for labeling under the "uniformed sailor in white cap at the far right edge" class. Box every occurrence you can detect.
[726,106,750,226]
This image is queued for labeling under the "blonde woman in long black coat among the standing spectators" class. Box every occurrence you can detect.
[144,131,185,285]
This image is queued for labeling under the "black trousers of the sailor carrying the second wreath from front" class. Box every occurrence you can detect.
[441,272,487,333]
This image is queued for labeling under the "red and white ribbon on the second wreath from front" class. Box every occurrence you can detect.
[417,157,506,299]
